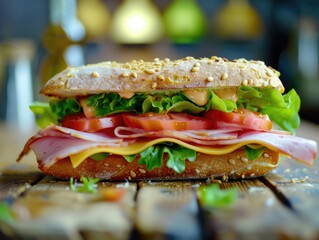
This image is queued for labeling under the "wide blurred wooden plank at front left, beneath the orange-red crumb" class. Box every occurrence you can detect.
[4,177,136,239]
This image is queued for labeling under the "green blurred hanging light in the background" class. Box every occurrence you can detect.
[163,0,206,43]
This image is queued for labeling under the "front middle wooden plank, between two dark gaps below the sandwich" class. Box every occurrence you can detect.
[136,182,201,239]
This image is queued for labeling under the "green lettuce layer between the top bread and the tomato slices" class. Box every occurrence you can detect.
[30,86,300,134]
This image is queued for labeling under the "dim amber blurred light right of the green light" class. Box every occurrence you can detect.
[213,0,262,40]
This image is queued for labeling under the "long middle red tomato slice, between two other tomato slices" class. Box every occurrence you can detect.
[122,113,212,131]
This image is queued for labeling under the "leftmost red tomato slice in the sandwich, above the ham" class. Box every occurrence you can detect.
[62,113,122,132]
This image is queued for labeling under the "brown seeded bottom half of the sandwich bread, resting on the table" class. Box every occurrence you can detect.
[39,149,279,181]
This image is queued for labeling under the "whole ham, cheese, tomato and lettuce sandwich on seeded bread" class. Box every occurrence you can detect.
[18,56,317,181]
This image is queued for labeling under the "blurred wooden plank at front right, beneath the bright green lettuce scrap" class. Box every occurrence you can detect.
[200,179,315,239]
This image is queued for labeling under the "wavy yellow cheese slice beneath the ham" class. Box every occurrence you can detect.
[70,138,247,168]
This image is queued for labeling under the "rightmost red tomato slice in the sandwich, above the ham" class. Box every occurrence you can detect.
[205,109,272,131]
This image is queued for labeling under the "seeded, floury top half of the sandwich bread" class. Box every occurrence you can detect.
[40,57,284,98]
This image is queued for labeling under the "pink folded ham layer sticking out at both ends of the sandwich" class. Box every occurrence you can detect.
[18,125,317,168]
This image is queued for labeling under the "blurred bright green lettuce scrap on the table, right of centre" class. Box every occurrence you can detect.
[197,184,237,208]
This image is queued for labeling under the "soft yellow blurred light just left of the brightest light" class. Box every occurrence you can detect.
[78,0,110,39]
